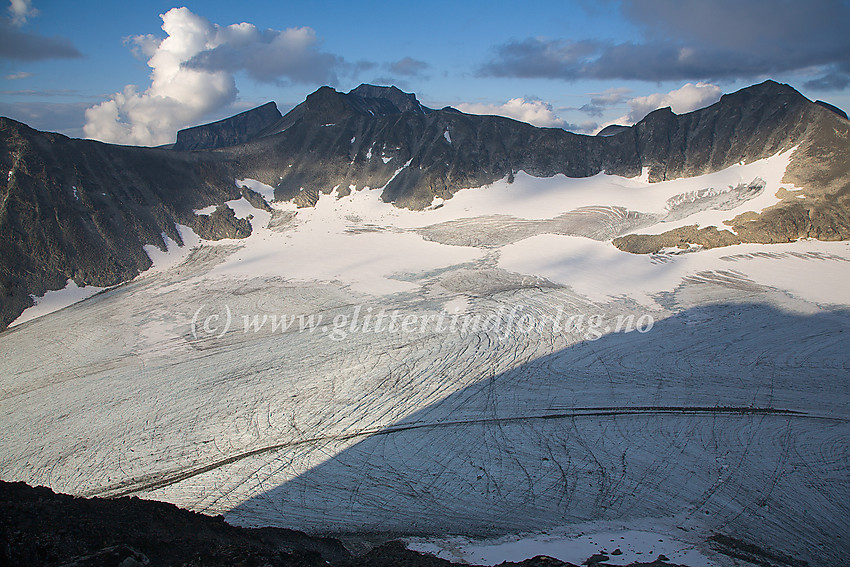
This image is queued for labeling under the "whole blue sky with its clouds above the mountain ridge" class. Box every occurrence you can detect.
[0,0,850,145]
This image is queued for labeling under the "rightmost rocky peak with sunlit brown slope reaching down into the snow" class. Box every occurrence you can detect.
[614,85,850,253]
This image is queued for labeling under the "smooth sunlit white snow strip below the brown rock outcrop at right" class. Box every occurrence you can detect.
[499,234,850,306]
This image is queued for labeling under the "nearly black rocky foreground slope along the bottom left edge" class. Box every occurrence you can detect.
[0,481,696,567]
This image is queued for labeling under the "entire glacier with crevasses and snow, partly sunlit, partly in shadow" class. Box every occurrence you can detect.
[0,152,850,566]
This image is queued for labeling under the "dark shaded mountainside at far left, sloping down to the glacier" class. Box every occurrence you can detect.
[0,118,240,329]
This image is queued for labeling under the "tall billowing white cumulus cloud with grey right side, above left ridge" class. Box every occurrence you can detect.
[84,7,342,146]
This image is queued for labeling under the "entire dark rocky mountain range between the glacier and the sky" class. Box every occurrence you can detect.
[0,81,850,329]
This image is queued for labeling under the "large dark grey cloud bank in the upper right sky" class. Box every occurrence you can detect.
[480,0,850,88]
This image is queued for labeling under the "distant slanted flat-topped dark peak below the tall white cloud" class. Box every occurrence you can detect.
[172,102,281,150]
